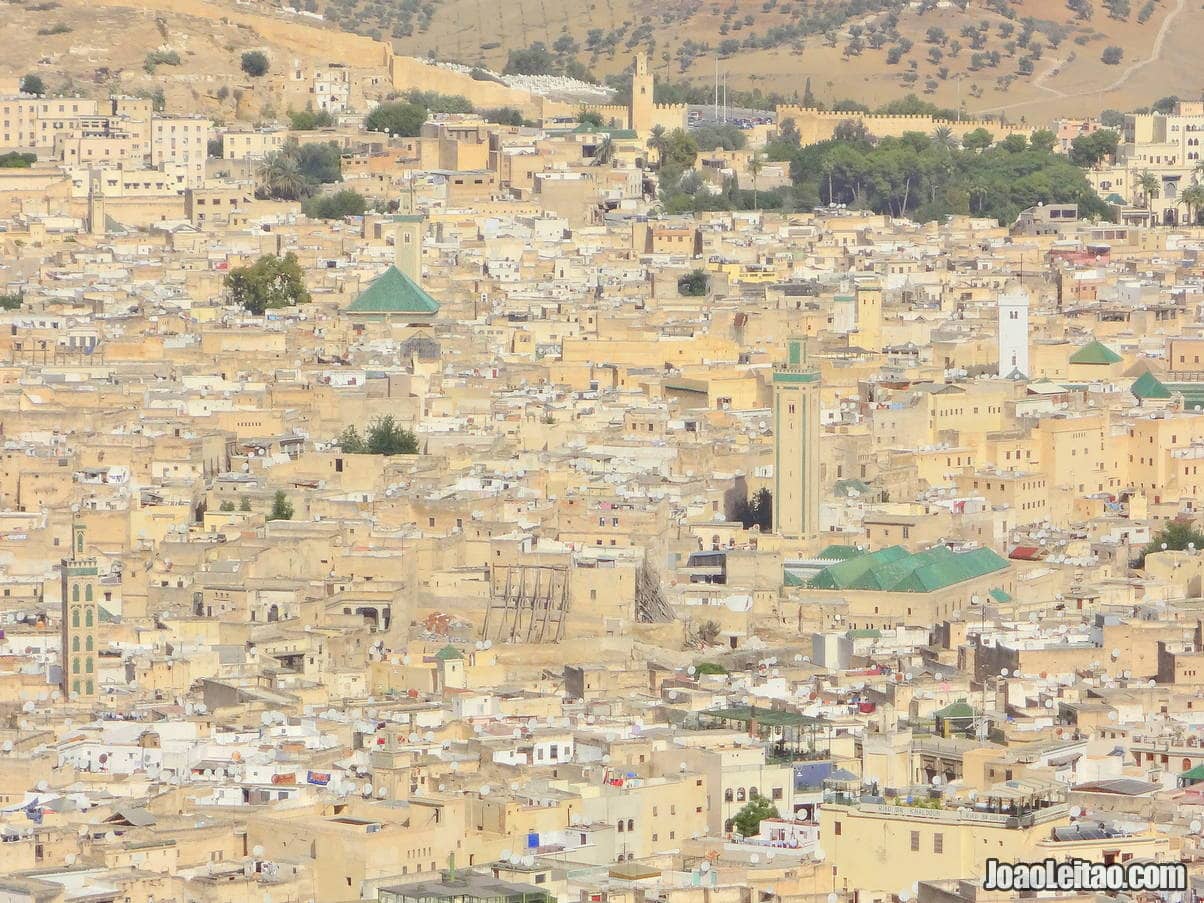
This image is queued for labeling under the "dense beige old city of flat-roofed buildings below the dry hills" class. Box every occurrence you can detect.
[0,8,1204,903]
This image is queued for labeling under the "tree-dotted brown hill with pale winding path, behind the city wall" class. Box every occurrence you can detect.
[334,0,1204,119]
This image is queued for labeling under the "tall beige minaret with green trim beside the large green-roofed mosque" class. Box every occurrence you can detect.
[773,338,820,539]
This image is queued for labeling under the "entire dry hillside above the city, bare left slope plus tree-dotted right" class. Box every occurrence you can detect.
[0,0,1204,122]
